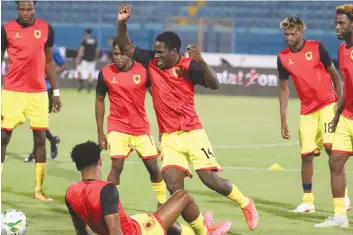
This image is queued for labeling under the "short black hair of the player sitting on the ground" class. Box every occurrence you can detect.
[71,141,102,171]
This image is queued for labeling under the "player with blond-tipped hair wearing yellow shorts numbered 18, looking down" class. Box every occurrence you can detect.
[277,17,351,213]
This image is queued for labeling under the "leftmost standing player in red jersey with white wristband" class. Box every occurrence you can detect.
[1,1,61,201]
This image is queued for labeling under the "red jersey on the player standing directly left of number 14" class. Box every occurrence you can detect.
[96,62,150,135]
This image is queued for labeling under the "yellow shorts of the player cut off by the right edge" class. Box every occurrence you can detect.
[332,115,353,155]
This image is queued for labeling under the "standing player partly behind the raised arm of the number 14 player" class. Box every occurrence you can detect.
[95,40,167,207]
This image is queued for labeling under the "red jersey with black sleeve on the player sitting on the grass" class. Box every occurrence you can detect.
[65,180,141,235]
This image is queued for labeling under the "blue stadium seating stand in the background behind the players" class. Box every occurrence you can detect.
[1,1,343,55]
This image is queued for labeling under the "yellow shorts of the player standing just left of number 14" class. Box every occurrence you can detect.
[108,131,159,160]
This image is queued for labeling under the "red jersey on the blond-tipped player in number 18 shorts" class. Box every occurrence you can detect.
[277,40,337,115]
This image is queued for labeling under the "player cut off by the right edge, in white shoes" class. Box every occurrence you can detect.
[315,4,353,228]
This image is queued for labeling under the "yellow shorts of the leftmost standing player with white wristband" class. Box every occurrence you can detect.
[1,90,49,131]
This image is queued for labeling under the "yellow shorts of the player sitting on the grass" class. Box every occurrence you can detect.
[131,213,167,235]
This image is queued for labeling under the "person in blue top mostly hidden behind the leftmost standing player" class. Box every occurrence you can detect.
[24,45,67,162]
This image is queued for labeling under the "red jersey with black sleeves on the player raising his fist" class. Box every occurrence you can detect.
[133,48,205,133]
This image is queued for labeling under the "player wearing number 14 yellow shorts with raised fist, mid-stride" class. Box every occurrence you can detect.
[117,6,259,230]
